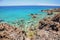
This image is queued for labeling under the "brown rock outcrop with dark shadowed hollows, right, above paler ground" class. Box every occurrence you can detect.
[38,14,60,31]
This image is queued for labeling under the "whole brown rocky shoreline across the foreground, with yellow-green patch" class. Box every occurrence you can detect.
[0,9,60,40]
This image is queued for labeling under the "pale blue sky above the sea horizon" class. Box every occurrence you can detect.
[0,0,60,6]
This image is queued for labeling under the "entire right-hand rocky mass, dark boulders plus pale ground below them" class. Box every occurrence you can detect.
[37,14,60,40]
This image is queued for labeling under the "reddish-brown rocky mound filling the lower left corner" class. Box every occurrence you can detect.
[0,23,22,40]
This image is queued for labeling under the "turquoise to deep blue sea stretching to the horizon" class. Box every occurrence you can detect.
[0,6,60,22]
